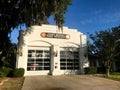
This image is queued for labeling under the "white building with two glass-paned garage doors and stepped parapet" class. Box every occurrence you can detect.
[16,25,89,76]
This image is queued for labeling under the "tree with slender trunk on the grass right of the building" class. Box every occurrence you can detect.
[90,26,120,77]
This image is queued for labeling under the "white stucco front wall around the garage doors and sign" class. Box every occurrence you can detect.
[16,25,89,76]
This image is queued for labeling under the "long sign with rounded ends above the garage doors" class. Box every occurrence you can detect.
[40,32,70,39]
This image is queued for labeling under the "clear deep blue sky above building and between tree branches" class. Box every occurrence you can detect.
[11,0,120,43]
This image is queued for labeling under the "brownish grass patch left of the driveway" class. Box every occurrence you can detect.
[0,77,24,90]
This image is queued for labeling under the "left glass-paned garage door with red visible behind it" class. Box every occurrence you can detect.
[27,47,51,71]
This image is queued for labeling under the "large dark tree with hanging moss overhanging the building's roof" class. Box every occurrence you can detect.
[0,0,71,67]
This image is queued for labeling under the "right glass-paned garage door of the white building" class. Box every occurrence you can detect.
[60,47,79,70]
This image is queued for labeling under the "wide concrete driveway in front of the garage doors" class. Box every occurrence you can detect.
[22,75,120,90]
